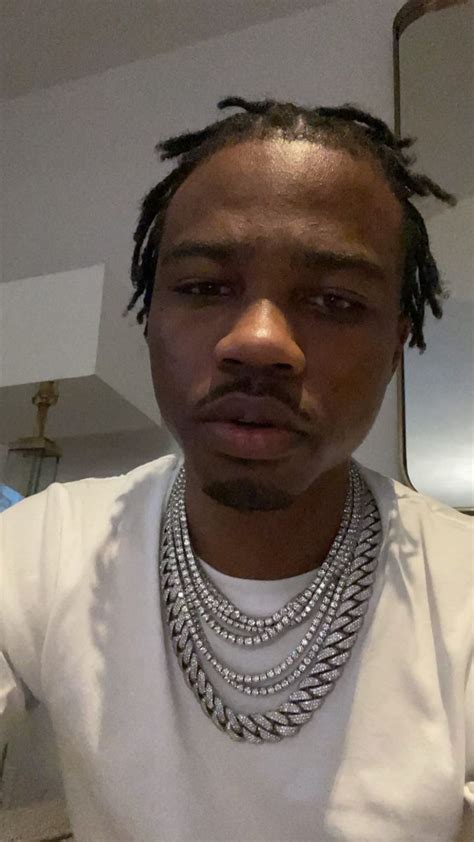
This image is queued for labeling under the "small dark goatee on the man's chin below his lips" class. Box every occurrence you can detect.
[202,479,295,512]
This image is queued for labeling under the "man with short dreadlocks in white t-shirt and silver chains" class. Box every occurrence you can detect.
[0,98,474,842]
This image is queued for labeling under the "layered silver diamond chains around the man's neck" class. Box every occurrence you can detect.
[160,462,381,743]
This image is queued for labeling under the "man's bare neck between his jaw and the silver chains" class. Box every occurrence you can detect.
[186,461,350,579]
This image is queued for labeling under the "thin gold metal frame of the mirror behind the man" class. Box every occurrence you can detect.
[393,0,474,515]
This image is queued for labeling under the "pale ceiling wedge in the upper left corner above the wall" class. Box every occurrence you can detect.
[0,0,329,99]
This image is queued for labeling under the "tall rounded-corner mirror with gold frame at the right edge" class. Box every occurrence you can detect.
[394,0,474,514]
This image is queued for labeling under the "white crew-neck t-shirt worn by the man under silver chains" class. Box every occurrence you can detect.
[0,455,474,842]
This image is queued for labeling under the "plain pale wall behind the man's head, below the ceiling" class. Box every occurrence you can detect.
[3,0,408,477]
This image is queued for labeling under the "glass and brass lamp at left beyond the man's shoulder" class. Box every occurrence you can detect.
[6,380,62,497]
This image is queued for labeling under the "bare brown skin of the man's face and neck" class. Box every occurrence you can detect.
[148,139,409,579]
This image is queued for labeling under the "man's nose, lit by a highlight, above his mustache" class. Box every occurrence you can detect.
[214,299,306,376]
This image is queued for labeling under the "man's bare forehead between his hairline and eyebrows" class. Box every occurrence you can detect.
[160,139,402,267]
